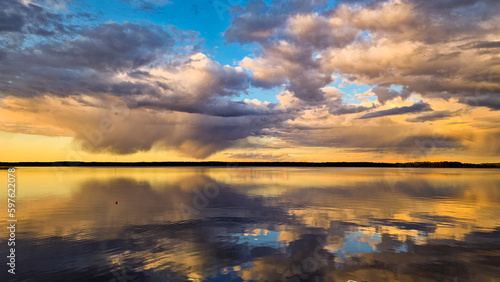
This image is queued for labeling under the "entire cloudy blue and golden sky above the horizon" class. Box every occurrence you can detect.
[0,0,500,163]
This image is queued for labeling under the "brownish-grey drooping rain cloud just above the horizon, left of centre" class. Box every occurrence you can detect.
[77,113,272,156]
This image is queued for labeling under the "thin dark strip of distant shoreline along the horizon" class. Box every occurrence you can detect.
[0,161,500,168]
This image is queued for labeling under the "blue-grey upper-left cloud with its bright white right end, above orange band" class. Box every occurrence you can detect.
[0,20,272,116]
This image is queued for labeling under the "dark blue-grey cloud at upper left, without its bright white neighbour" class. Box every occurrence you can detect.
[0,23,182,96]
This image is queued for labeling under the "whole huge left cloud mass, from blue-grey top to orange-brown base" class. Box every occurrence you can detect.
[0,12,282,158]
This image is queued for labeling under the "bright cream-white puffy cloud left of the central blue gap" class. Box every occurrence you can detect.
[124,53,256,116]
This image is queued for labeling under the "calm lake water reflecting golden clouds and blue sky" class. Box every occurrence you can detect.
[0,168,500,281]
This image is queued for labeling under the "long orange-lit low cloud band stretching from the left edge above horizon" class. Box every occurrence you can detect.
[0,96,281,158]
